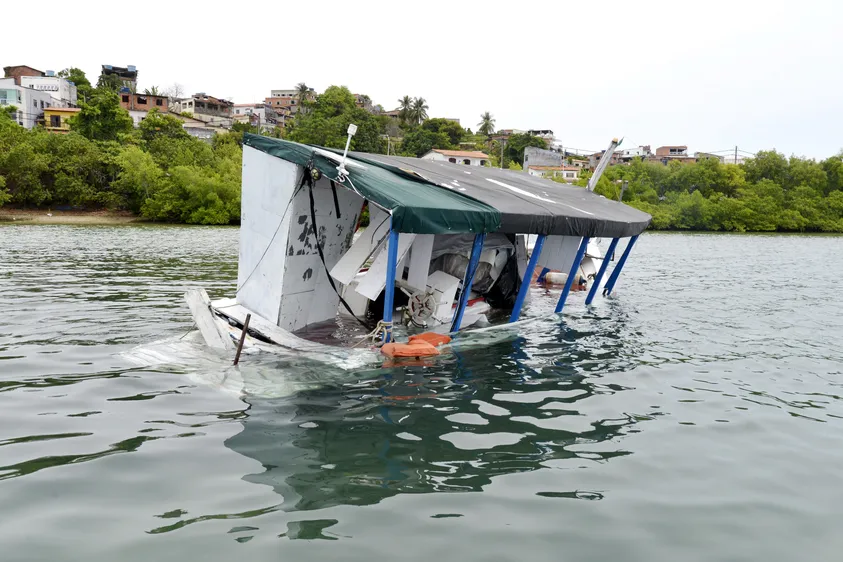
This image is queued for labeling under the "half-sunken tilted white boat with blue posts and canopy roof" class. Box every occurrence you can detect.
[185,130,651,368]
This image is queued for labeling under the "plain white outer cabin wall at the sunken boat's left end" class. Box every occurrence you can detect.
[237,146,304,322]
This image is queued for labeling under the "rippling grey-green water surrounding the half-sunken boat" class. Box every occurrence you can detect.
[0,226,843,562]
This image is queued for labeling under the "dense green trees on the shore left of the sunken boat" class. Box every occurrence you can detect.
[0,87,242,224]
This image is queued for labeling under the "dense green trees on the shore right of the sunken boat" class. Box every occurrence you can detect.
[578,151,843,232]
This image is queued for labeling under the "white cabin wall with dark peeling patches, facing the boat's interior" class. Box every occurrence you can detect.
[274,178,363,331]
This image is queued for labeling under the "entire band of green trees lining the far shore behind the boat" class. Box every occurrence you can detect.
[0,75,843,232]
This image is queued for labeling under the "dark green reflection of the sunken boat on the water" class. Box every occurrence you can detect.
[226,322,652,511]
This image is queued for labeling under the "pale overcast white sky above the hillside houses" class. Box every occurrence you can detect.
[6,0,843,158]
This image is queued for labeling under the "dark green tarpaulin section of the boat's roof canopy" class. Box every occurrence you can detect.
[243,133,501,234]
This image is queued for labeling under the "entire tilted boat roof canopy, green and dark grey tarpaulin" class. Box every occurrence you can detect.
[243,134,652,238]
